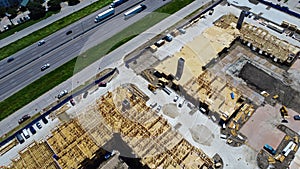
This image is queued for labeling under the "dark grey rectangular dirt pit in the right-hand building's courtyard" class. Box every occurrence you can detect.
[239,63,300,112]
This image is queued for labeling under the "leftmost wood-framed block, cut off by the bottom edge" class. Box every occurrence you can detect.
[8,141,59,169]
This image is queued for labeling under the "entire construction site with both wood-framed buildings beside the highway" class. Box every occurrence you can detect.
[3,2,300,169]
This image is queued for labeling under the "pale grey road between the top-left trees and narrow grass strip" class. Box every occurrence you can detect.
[0,0,97,48]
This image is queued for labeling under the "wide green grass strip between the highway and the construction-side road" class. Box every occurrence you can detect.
[0,0,194,123]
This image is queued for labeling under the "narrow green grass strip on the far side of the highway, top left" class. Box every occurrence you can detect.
[0,0,112,60]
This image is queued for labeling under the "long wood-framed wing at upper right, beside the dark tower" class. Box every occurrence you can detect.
[214,15,300,66]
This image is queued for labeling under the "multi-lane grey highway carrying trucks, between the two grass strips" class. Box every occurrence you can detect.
[0,0,169,101]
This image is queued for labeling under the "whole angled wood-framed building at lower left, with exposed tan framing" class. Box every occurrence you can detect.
[5,84,214,169]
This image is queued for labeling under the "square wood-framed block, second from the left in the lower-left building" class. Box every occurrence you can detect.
[47,120,99,168]
